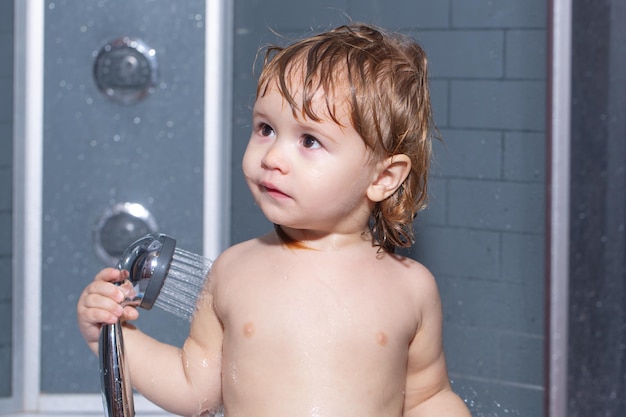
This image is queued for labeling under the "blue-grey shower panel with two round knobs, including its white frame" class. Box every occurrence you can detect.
[2,0,232,414]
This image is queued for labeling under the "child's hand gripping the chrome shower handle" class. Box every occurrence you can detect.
[76,268,139,352]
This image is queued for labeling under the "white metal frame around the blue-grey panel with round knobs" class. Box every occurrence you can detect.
[7,0,233,417]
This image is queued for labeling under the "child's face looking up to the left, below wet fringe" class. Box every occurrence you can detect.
[243,81,376,233]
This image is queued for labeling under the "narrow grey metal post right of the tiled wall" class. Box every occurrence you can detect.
[545,0,572,417]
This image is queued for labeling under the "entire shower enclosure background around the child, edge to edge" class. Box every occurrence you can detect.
[0,0,626,417]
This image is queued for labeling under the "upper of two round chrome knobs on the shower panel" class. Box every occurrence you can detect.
[94,37,157,104]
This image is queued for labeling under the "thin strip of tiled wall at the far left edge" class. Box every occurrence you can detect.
[0,0,13,398]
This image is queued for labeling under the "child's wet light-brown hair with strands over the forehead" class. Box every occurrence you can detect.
[257,23,435,252]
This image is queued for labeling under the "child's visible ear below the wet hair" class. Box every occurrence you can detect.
[367,154,411,203]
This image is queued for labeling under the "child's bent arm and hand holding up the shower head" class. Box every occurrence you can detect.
[77,268,223,416]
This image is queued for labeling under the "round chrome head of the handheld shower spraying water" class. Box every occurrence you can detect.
[117,233,176,310]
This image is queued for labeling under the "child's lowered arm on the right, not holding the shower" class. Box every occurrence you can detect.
[404,271,471,417]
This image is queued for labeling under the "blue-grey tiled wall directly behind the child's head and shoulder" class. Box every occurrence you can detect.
[232,0,547,417]
